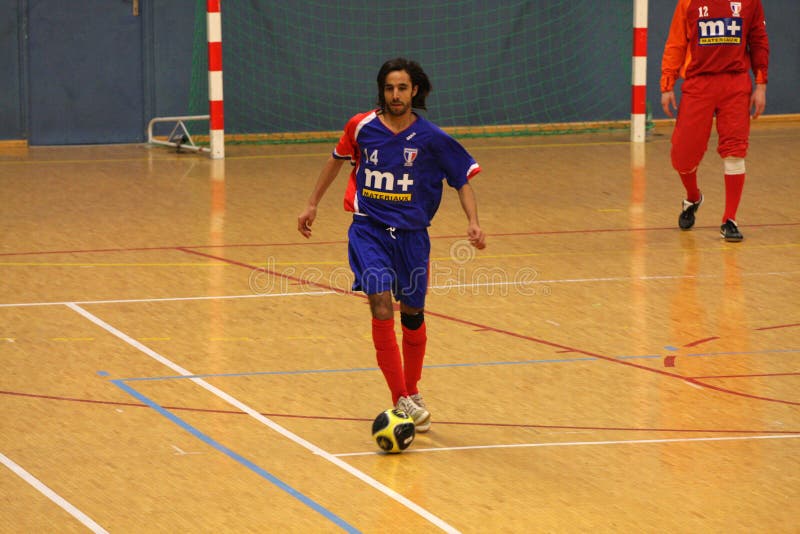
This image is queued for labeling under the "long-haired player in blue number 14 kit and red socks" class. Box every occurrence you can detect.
[297,58,486,432]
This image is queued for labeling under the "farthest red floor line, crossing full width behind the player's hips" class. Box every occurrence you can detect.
[0,222,800,257]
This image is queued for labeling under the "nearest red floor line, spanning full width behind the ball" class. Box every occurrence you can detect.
[0,390,800,434]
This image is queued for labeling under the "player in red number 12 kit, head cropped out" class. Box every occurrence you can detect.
[661,0,769,242]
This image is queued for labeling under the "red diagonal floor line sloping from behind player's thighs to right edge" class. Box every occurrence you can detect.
[179,248,800,406]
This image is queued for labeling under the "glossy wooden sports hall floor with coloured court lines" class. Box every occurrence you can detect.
[0,118,800,533]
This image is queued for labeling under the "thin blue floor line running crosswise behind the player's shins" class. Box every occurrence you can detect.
[118,349,800,382]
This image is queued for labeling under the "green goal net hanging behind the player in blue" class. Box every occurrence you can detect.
[190,0,633,142]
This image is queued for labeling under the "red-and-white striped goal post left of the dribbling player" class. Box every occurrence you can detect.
[206,0,225,159]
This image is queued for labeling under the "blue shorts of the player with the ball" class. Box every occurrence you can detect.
[348,215,431,308]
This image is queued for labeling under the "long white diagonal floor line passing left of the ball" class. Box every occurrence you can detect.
[66,302,459,533]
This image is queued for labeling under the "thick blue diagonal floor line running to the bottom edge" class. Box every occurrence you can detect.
[110,380,360,533]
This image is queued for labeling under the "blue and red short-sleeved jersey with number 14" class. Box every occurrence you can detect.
[333,110,481,230]
